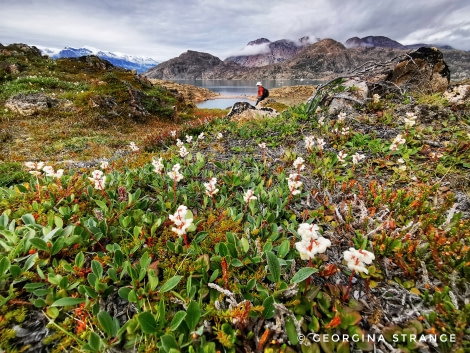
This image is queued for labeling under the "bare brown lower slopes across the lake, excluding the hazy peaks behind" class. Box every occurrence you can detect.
[144,39,470,80]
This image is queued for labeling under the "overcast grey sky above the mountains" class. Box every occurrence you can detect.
[0,0,470,62]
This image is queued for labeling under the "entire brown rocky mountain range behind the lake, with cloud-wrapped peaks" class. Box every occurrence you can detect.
[144,36,470,80]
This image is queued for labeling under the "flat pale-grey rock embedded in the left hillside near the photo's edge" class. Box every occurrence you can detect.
[5,93,59,116]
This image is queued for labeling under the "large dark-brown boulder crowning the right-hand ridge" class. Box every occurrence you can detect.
[386,47,450,93]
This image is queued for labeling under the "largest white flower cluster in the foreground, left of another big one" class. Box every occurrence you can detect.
[295,223,331,260]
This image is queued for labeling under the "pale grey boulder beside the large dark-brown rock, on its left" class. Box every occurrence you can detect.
[328,79,369,115]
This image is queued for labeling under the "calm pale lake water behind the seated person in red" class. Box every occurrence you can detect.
[175,79,321,109]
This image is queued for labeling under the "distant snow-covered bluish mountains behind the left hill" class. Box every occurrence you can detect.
[39,47,158,73]
